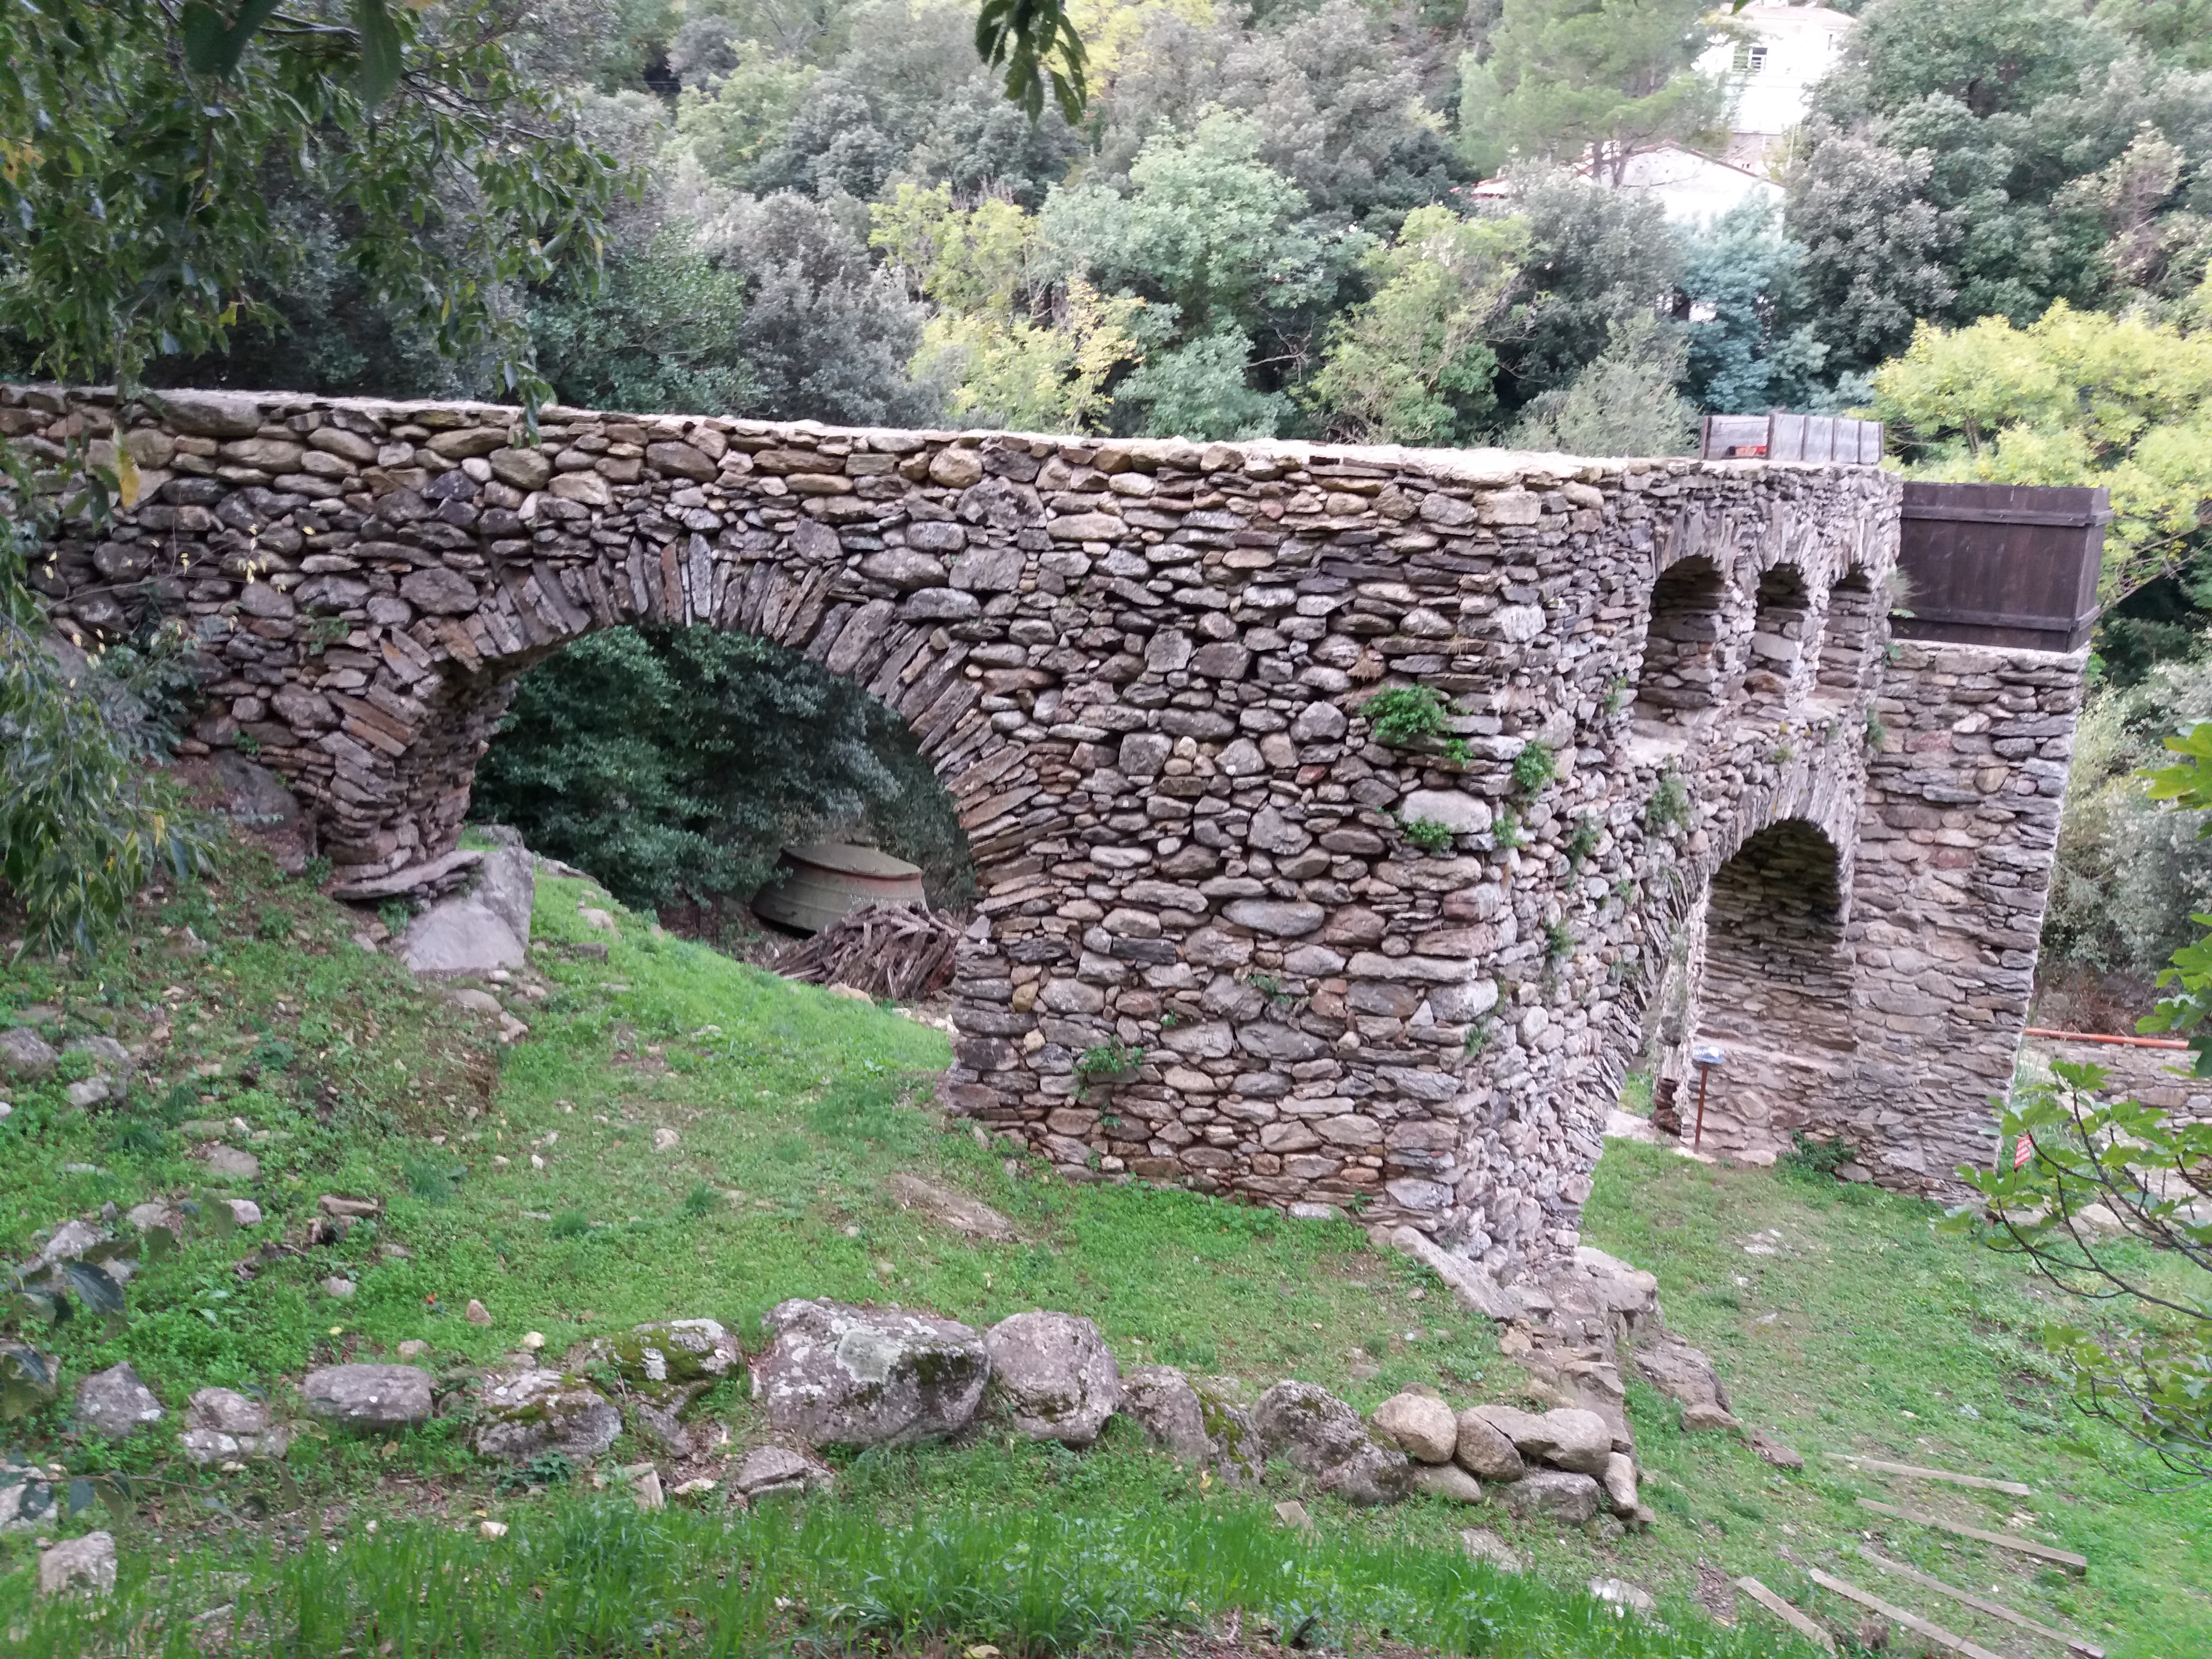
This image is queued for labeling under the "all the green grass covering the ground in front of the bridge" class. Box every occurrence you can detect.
[0,836,2212,1659]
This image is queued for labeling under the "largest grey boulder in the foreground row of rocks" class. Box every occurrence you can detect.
[752,1301,991,1447]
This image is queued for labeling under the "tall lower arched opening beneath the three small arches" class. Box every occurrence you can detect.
[1681,818,1854,1157]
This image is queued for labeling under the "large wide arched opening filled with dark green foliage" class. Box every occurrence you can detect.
[471,626,975,947]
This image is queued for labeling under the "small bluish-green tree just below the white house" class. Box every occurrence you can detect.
[1681,199,1827,414]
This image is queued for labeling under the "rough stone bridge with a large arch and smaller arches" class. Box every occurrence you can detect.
[13,390,2081,1265]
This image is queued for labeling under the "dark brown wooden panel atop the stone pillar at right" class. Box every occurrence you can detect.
[1889,480,2112,651]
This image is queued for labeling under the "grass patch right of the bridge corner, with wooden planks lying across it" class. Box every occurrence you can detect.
[1584,1141,2212,1659]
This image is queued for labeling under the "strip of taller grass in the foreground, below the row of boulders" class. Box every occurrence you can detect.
[0,1498,1812,1659]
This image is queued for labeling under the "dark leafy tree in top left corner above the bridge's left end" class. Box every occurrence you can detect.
[0,0,617,402]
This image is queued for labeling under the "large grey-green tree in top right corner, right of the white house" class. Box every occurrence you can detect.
[1790,0,2212,369]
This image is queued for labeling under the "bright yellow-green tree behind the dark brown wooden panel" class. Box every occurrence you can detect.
[1873,303,2212,600]
